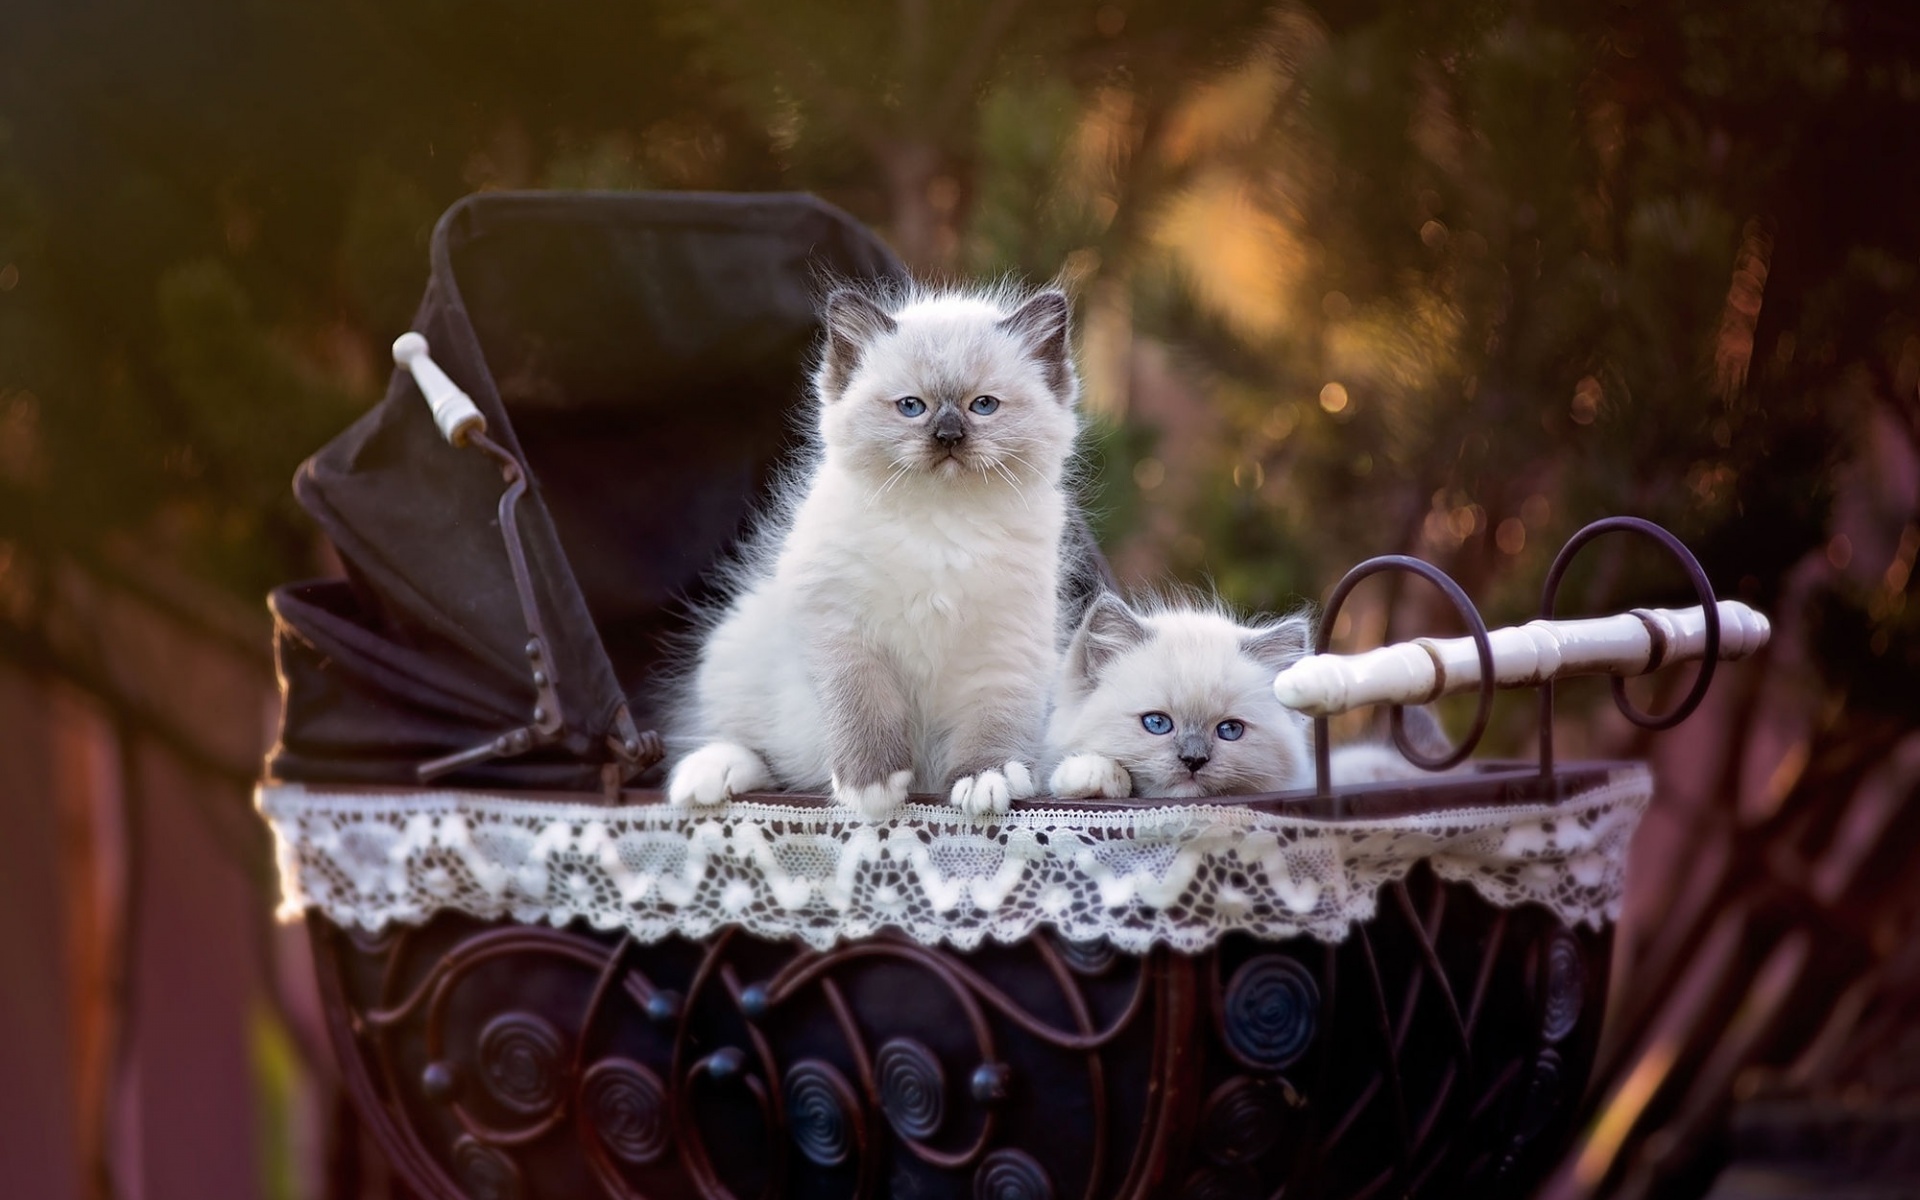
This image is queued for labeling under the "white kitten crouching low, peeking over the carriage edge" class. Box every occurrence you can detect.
[1046,593,1313,799]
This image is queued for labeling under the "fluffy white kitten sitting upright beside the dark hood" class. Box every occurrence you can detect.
[666,290,1079,818]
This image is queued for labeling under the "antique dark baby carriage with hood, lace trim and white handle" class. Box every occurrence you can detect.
[259,194,1764,1198]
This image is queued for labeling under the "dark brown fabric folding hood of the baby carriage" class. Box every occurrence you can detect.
[267,192,904,787]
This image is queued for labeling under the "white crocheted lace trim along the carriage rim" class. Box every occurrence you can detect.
[255,766,1653,952]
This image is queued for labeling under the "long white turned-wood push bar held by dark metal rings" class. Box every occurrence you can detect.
[1273,601,1772,716]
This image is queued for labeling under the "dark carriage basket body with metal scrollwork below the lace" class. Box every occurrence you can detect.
[313,868,1605,1200]
